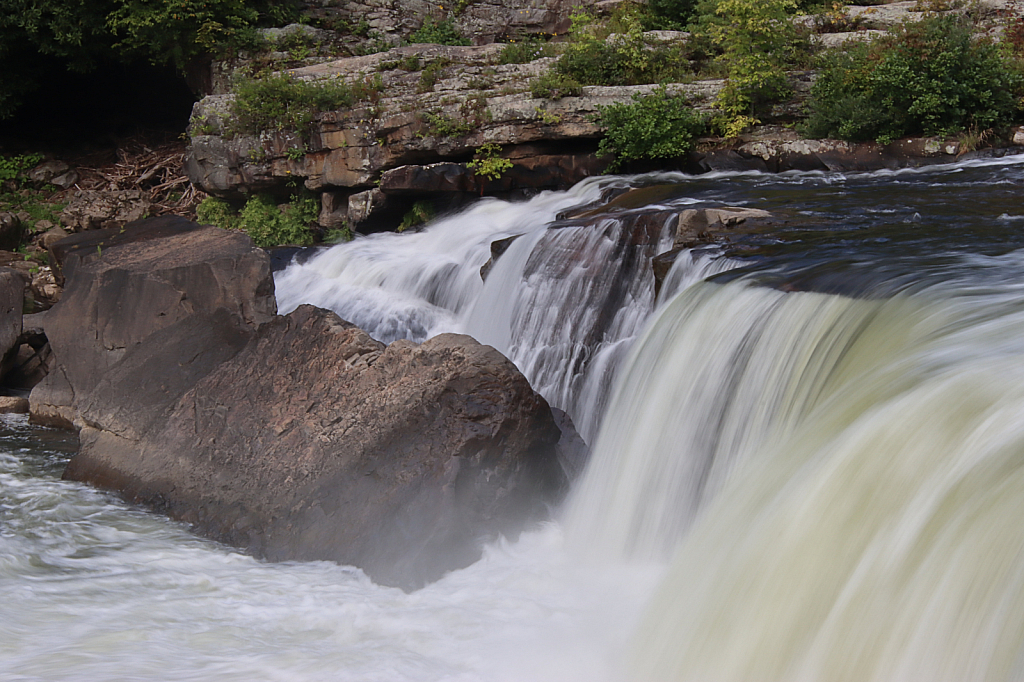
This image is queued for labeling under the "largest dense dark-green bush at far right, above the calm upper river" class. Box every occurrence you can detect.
[806,15,1024,143]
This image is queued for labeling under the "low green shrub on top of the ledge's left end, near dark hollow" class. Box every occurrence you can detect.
[231,74,360,135]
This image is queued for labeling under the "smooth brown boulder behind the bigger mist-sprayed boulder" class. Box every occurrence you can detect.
[31,217,276,426]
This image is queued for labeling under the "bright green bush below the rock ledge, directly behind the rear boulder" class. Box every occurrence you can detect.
[196,194,319,249]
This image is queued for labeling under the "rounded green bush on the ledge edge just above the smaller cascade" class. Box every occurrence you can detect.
[597,87,707,170]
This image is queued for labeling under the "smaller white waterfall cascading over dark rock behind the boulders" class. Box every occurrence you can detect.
[276,176,732,440]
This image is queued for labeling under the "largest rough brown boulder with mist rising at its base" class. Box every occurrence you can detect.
[65,305,565,588]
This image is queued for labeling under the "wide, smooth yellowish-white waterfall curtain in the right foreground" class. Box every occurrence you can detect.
[566,274,1024,682]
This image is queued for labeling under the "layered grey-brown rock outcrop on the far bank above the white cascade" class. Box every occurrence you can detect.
[185,38,722,225]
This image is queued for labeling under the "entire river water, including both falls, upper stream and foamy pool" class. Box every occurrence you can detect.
[6,157,1024,682]
